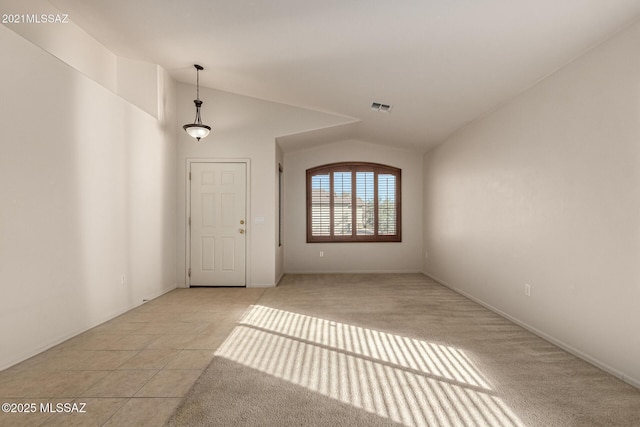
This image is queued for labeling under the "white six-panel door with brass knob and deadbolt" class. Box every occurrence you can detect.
[190,163,247,286]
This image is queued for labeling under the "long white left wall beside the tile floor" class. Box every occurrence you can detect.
[0,26,176,369]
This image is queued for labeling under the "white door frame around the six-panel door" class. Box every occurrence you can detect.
[184,158,252,288]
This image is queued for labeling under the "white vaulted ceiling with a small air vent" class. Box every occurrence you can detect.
[51,0,640,151]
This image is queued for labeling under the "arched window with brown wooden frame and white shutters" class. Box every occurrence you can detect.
[307,162,402,243]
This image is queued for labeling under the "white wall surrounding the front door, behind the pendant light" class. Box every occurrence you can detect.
[177,86,356,286]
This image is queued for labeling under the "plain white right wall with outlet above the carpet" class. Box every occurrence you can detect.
[424,20,640,386]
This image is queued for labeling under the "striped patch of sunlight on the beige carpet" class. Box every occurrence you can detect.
[216,305,523,427]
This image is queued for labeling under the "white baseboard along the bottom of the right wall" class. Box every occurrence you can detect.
[422,271,640,389]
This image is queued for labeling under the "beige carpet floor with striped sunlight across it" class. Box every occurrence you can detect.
[168,274,640,427]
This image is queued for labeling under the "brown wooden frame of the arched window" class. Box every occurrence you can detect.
[306,162,402,243]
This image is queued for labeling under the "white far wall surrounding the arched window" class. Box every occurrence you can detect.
[284,140,422,273]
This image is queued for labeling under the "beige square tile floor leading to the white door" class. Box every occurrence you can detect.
[0,288,264,426]
